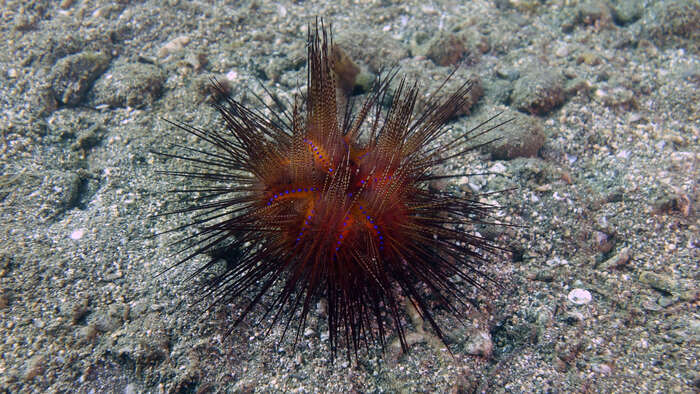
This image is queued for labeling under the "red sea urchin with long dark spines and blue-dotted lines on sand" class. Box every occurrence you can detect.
[154,23,505,358]
